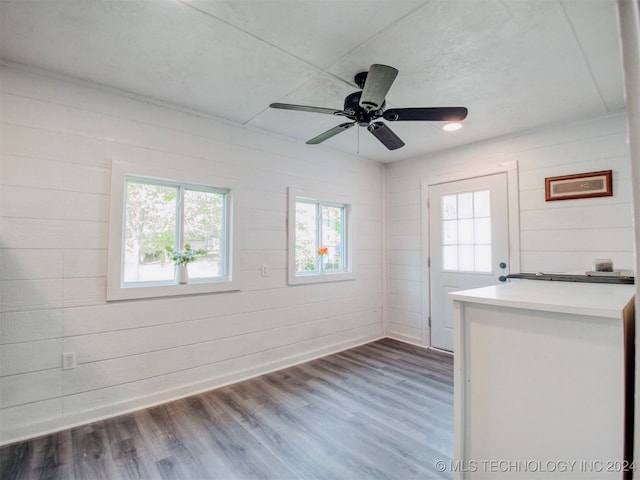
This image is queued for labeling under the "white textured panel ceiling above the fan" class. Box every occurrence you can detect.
[0,0,624,162]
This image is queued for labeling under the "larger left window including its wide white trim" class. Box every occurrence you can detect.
[107,165,236,300]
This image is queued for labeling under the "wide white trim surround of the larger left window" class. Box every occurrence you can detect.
[107,162,239,301]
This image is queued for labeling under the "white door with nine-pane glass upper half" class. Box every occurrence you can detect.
[429,173,509,351]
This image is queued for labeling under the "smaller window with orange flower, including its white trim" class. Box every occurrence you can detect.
[289,188,355,284]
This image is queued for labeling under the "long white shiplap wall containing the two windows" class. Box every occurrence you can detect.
[0,65,385,443]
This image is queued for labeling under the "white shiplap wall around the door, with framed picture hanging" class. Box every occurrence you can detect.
[387,113,634,343]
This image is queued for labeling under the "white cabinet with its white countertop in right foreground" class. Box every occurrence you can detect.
[451,280,634,479]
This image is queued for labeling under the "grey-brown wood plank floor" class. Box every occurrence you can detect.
[0,339,453,480]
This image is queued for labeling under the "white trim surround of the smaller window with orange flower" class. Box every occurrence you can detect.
[287,188,356,285]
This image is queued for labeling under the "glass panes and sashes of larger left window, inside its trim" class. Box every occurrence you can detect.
[122,177,227,286]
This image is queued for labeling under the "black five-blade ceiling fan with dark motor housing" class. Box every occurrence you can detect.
[269,64,468,150]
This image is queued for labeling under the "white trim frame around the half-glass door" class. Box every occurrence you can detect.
[420,160,520,347]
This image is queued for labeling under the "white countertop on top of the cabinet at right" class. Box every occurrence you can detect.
[449,279,636,318]
